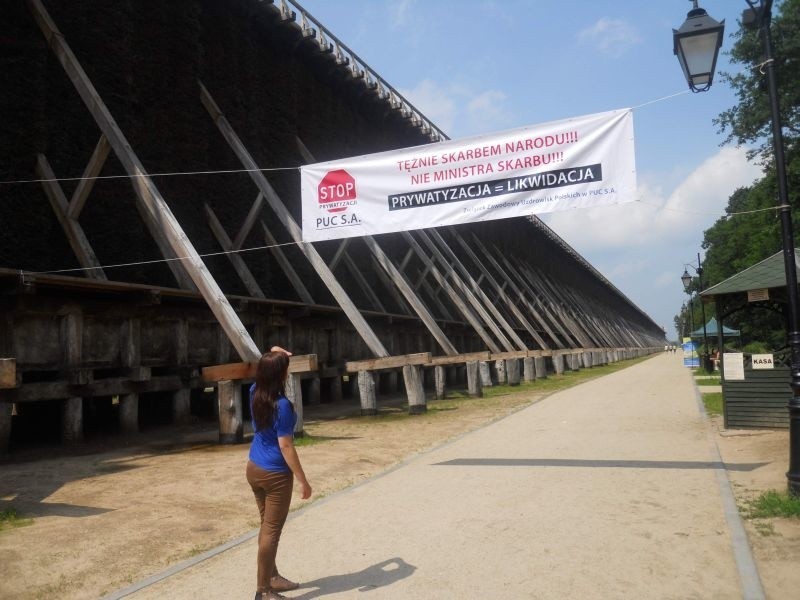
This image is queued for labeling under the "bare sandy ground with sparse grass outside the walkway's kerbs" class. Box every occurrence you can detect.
[0,358,800,600]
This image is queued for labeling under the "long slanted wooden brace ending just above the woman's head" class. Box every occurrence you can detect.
[29,0,261,360]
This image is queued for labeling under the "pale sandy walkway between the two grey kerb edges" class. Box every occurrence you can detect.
[117,354,760,600]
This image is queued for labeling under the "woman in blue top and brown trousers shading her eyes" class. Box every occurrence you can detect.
[247,346,311,600]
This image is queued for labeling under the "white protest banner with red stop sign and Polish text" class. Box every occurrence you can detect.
[300,109,636,242]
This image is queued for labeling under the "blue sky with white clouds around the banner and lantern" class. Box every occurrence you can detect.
[301,0,764,338]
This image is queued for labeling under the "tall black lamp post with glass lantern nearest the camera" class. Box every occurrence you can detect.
[673,0,800,496]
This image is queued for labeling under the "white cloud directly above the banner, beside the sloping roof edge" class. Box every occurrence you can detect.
[399,79,511,137]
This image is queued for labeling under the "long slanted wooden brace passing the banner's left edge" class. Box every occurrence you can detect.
[199,83,389,356]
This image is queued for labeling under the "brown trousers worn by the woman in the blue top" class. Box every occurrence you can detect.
[247,460,294,592]
